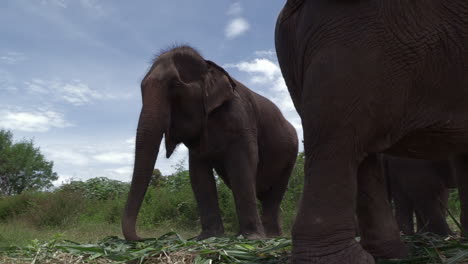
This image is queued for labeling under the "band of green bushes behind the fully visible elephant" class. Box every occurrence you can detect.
[0,153,304,234]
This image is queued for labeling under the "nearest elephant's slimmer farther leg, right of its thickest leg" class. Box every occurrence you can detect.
[357,154,408,259]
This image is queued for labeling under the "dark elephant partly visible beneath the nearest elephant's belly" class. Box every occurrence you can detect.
[384,156,456,236]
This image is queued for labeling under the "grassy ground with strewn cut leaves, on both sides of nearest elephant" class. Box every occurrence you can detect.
[0,221,468,264]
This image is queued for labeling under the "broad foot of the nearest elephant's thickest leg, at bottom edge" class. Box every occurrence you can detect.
[291,240,375,264]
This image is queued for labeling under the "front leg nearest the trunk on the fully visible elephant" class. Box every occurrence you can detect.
[189,153,224,239]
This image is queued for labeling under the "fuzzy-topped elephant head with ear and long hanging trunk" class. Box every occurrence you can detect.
[122,46,236,240]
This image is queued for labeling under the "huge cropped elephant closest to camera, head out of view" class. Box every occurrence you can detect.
[275,0,468,264]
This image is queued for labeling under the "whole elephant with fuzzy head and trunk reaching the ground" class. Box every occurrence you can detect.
[122,46,298,240]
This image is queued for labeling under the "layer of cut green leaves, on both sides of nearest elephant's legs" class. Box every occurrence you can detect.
[0,232,468,264]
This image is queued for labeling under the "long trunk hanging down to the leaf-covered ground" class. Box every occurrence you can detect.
[122,100,169,241]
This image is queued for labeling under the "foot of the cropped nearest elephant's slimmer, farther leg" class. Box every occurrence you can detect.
[361,240,409,259]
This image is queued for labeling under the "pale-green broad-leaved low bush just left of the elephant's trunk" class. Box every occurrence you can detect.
[60,177,129,200]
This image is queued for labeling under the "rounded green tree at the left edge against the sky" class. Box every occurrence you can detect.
[0,130,58,195]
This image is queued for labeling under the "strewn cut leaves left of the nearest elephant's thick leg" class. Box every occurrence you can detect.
[0,232,291,264]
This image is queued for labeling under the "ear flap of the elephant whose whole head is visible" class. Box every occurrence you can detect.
[204,60,236,113]
